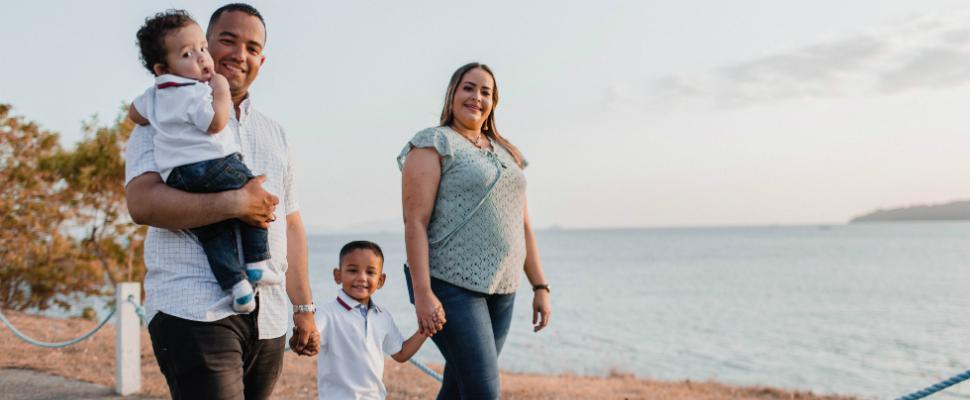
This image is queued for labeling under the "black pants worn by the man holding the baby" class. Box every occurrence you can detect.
[148,296,285,400]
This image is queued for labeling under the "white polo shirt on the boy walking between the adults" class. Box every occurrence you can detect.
[316,289,404,400]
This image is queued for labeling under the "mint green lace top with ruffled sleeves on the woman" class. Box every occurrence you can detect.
[397,127,526,294]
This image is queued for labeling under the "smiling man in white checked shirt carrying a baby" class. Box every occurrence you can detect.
[125,4,319,399]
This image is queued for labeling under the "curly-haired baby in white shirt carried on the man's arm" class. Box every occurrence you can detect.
[128,10,281,313]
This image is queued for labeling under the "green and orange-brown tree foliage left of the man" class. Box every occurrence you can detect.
[0,104,145,310]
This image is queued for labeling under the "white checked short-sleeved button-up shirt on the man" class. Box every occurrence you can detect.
[125,99,299,339]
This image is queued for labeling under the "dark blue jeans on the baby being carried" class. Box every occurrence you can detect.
[165,153,270,290]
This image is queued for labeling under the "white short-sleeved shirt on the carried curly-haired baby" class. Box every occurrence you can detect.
[132,74,239,180]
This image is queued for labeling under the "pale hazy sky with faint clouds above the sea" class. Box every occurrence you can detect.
[0,0,970,232]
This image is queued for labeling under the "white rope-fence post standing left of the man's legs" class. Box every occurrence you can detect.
[115,282,141,396]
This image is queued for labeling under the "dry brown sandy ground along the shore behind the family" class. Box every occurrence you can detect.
[0,311,852,400]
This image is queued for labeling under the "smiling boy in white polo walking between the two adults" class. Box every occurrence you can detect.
[316,240,427,400]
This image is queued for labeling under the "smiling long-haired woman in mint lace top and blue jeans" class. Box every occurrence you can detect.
[398,63,551,399]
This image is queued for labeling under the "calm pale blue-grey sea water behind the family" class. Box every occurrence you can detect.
[309,223,970,398]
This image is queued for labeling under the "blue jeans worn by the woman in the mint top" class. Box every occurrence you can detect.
[405,271,515,400]
